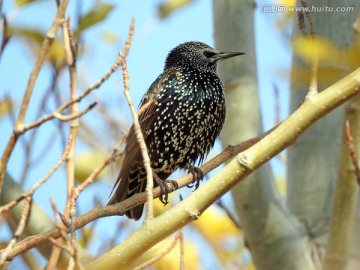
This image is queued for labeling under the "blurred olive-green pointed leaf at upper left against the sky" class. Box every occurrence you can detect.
[75,3,114,35]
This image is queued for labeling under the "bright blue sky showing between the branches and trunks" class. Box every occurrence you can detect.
[0,0,290,266]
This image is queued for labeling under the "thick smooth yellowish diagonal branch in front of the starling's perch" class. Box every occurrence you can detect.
[87,69,360,270]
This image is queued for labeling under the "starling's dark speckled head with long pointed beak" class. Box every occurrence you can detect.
[165,41,244,72]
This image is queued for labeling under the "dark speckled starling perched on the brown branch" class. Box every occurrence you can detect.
[108,42,243,220]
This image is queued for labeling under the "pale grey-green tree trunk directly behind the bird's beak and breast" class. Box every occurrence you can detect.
[213,0,314,270]
